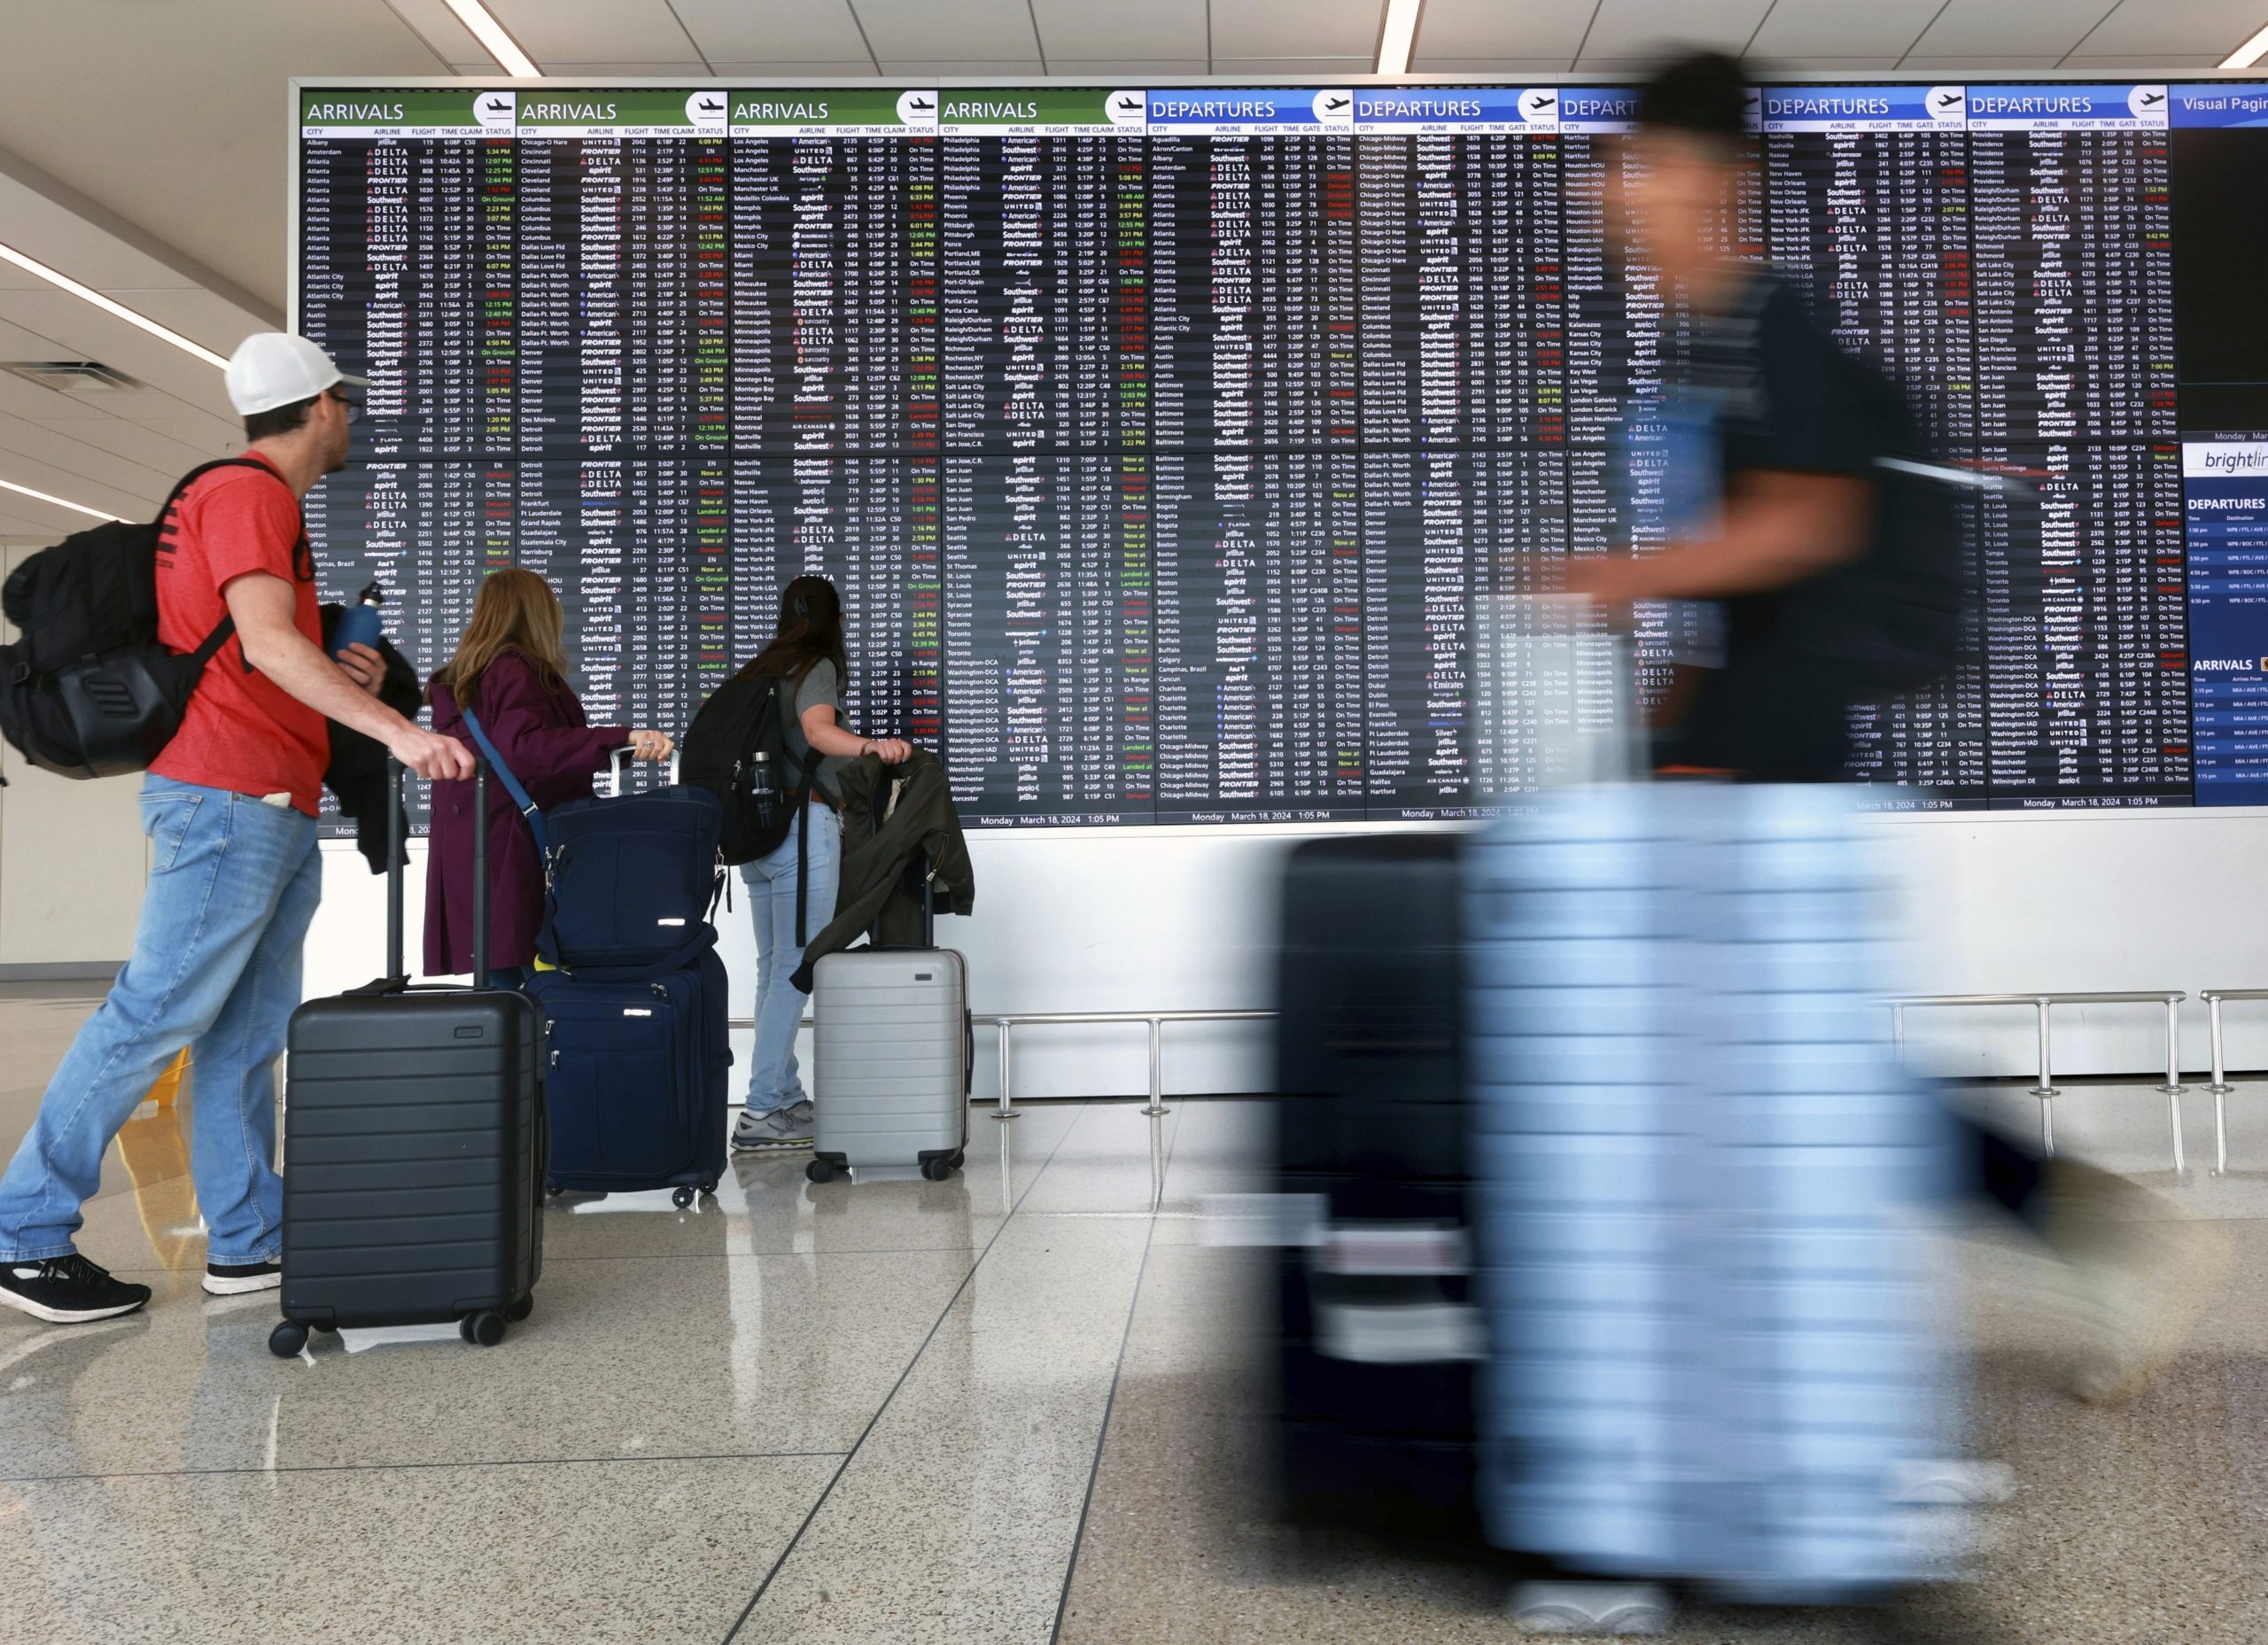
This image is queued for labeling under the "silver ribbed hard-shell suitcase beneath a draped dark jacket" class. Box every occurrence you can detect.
[805,949,973,1182]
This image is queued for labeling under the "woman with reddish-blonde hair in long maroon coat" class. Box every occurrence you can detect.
[424,567,669,987]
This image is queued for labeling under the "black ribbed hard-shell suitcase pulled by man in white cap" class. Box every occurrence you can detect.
[268,763,547,1357]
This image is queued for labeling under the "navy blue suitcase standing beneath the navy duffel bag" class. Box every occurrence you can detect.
[528,949,733,1207]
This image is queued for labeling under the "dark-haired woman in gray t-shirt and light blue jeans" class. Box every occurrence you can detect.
[733,577,912,1152]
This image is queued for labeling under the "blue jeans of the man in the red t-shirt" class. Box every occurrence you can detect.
[0,776,322,1264]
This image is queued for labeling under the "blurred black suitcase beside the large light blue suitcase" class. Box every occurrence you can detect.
[1277,833,1481,1543]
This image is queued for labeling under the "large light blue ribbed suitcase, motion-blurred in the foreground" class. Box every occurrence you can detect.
[1467,783,1948,1600]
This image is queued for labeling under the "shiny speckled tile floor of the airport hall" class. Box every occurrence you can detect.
[0,1001,2268,1645]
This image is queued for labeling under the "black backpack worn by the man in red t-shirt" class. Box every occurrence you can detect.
[0,456,307,779]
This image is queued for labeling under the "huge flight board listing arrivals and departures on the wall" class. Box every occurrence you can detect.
[295,84,2268,826]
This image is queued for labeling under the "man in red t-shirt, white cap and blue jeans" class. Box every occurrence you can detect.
[0,331,471,1323]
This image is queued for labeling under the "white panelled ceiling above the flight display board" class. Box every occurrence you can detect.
[0,0,2268,540]
